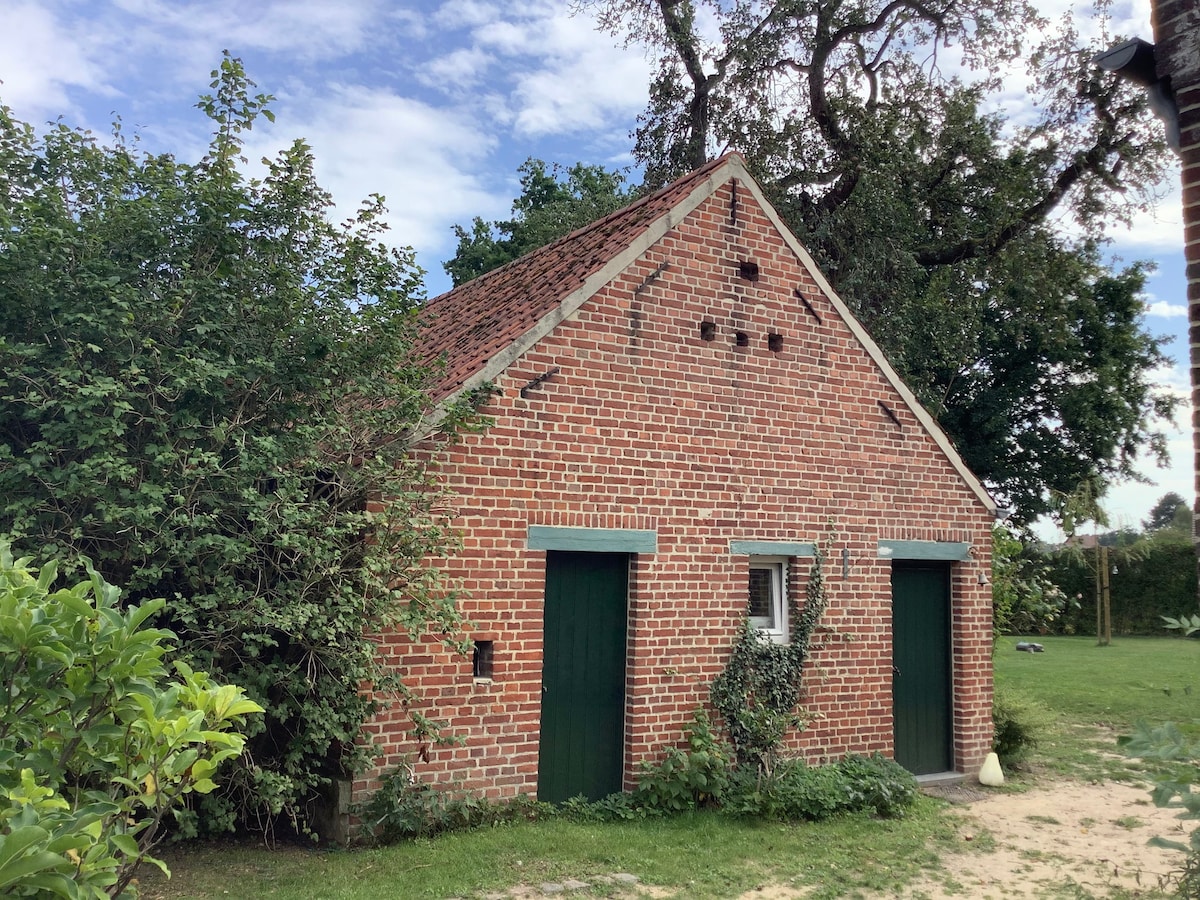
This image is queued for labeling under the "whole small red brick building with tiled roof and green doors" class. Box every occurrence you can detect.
[354,155,995,800]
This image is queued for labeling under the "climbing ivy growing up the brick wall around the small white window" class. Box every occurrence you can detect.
[712,545,828,770]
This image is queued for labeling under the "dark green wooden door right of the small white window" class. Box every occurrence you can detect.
[892,562,954,775]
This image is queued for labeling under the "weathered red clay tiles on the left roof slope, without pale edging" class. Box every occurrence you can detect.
[420,154,734,398]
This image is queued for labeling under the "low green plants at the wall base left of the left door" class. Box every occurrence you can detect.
[355,766,554,844]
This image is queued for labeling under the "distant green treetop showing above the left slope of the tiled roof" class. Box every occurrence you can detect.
[444,158,632,287]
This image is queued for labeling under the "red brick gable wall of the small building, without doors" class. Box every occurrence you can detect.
[358,185,991,797]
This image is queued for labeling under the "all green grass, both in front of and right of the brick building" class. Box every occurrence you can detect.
[144,637,1200,900]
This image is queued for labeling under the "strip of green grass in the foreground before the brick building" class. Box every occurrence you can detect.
[146,811,953,900]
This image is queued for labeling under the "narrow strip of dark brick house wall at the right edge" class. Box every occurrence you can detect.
[1153,0,1200,561]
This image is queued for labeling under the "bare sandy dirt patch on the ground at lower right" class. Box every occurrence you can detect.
[883,784,1184,900]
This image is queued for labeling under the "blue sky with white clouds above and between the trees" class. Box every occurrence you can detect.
[0,0,1193,535]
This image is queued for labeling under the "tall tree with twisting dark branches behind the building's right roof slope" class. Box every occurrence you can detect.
[580,0,1172,522]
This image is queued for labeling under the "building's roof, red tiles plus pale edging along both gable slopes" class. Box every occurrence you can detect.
[418,152,996,514]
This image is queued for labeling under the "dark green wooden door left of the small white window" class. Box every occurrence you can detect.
[538,551,629,803]
